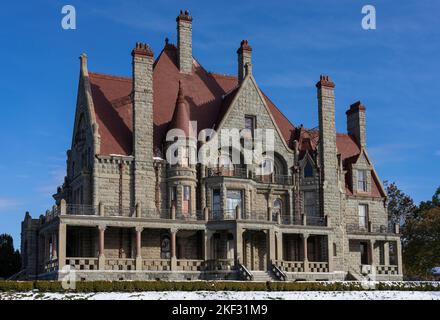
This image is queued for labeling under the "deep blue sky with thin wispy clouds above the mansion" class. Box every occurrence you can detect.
[0,0,440,245]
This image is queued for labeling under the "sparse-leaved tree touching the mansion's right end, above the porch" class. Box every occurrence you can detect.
[384,181,417,227]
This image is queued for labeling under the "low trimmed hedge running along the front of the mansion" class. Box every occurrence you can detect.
[0,281,440,292]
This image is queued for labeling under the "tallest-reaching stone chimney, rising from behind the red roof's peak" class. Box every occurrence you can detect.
[176,10,193,74]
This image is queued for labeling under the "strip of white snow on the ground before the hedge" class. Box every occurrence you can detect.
[0,291,440,300]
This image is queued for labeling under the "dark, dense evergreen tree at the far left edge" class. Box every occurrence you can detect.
[0,234,21,279]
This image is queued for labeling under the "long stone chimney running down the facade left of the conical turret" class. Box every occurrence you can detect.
[131,43,155,208]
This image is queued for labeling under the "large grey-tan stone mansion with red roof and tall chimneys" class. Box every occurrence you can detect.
[21,11,402,281]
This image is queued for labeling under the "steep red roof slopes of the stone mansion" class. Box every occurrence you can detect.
[89,44,380,196]
